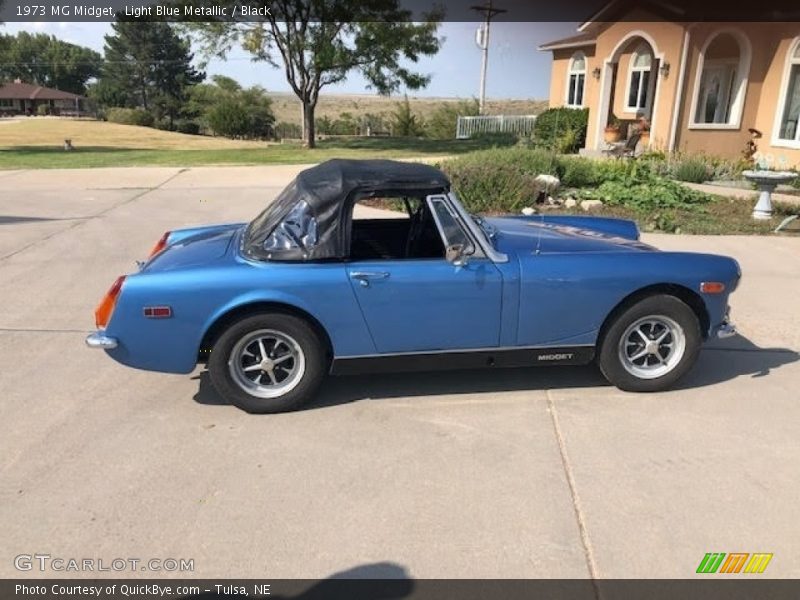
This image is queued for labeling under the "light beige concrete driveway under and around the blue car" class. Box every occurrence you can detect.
[0,167,800,578]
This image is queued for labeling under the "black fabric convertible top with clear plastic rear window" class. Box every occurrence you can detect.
[243,159,450,260]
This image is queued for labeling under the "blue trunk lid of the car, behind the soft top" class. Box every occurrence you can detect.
[142,223,246,272]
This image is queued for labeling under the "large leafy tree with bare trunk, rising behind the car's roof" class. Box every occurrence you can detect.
[184,0,442,148]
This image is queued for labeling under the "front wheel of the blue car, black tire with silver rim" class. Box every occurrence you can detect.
[597,295,702,392]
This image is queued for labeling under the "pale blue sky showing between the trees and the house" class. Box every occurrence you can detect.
[0,22,578,99]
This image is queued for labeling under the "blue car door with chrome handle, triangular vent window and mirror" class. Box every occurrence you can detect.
[347,195,503,353]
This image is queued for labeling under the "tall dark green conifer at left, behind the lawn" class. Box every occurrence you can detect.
[95,16,205,128]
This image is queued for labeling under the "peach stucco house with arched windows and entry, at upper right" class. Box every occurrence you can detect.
[539,0,800,167]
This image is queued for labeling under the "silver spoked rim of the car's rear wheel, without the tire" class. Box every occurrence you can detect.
[228,329,306,398]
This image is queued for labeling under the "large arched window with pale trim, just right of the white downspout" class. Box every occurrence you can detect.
[692,32,750,128]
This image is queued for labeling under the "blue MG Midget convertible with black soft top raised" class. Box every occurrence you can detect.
[86,160,741,413]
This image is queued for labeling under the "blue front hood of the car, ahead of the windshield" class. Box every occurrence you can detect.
[486,215,657,254]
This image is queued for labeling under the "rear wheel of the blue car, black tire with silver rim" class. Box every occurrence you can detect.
[208,312,328,414]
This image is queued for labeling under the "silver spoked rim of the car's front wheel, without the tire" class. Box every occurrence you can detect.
[619,315,686,379]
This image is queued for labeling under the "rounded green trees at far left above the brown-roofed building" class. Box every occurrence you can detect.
[0,31,103,94]
